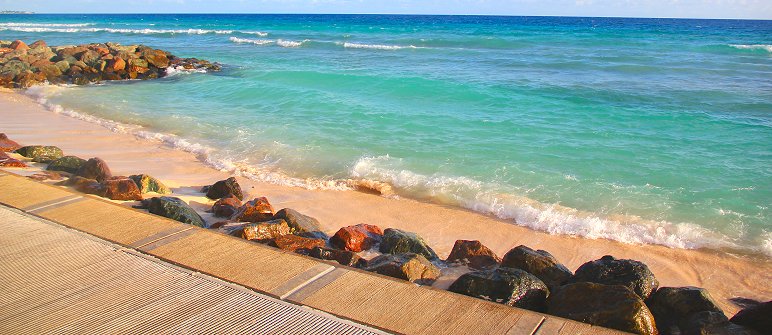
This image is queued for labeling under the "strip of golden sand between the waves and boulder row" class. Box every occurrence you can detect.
[0,90,772,315]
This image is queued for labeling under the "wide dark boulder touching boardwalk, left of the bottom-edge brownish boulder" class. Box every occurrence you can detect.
[448,268,550,312]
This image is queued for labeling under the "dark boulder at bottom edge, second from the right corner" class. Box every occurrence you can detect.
[646,286,728,334]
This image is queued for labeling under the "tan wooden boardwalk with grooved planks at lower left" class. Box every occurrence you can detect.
[0,170,621,335]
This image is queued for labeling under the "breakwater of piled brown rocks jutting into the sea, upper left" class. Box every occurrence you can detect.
[0,40,221,88]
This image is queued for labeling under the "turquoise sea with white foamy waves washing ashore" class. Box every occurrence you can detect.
[0,15,772,255]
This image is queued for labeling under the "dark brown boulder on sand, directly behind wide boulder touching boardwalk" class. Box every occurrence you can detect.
[501,245,573,290]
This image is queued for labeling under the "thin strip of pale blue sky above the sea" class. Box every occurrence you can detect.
[0,0,772,20]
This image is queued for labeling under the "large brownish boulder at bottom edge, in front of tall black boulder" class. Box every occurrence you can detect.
[547,282,658,335]
